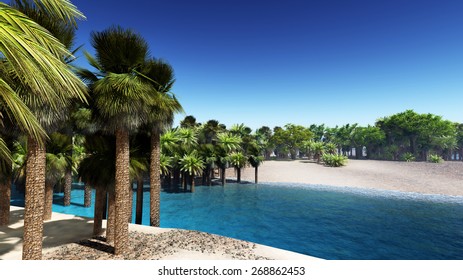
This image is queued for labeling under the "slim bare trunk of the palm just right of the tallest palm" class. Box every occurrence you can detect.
[150,129,161,227]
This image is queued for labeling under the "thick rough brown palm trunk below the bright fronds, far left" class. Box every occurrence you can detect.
[22,137,46,260]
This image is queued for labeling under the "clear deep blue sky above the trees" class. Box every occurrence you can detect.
[72,0,463,129]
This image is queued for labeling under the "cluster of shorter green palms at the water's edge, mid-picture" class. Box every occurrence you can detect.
[160,120,264,192]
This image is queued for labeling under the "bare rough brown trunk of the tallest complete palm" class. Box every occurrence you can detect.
[114,129,130,255]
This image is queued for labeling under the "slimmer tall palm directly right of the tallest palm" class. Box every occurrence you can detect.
[143,59,182,227]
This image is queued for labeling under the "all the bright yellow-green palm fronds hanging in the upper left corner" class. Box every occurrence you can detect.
[0,0,86,144]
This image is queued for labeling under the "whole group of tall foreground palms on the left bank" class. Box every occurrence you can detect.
[0,0,181,259]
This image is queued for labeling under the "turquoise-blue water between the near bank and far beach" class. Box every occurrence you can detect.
[10,184,463,259]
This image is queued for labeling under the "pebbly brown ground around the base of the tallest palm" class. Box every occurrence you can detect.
[43,230,267,260]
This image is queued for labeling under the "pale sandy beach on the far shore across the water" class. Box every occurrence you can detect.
[237,160,463,196]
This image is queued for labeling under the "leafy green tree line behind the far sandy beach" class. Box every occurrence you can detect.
[256,110,463,161]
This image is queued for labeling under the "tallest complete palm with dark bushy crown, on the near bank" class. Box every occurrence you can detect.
[87,27,154,255]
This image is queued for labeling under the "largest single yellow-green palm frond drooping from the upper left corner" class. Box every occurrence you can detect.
[0,3,86,109]
